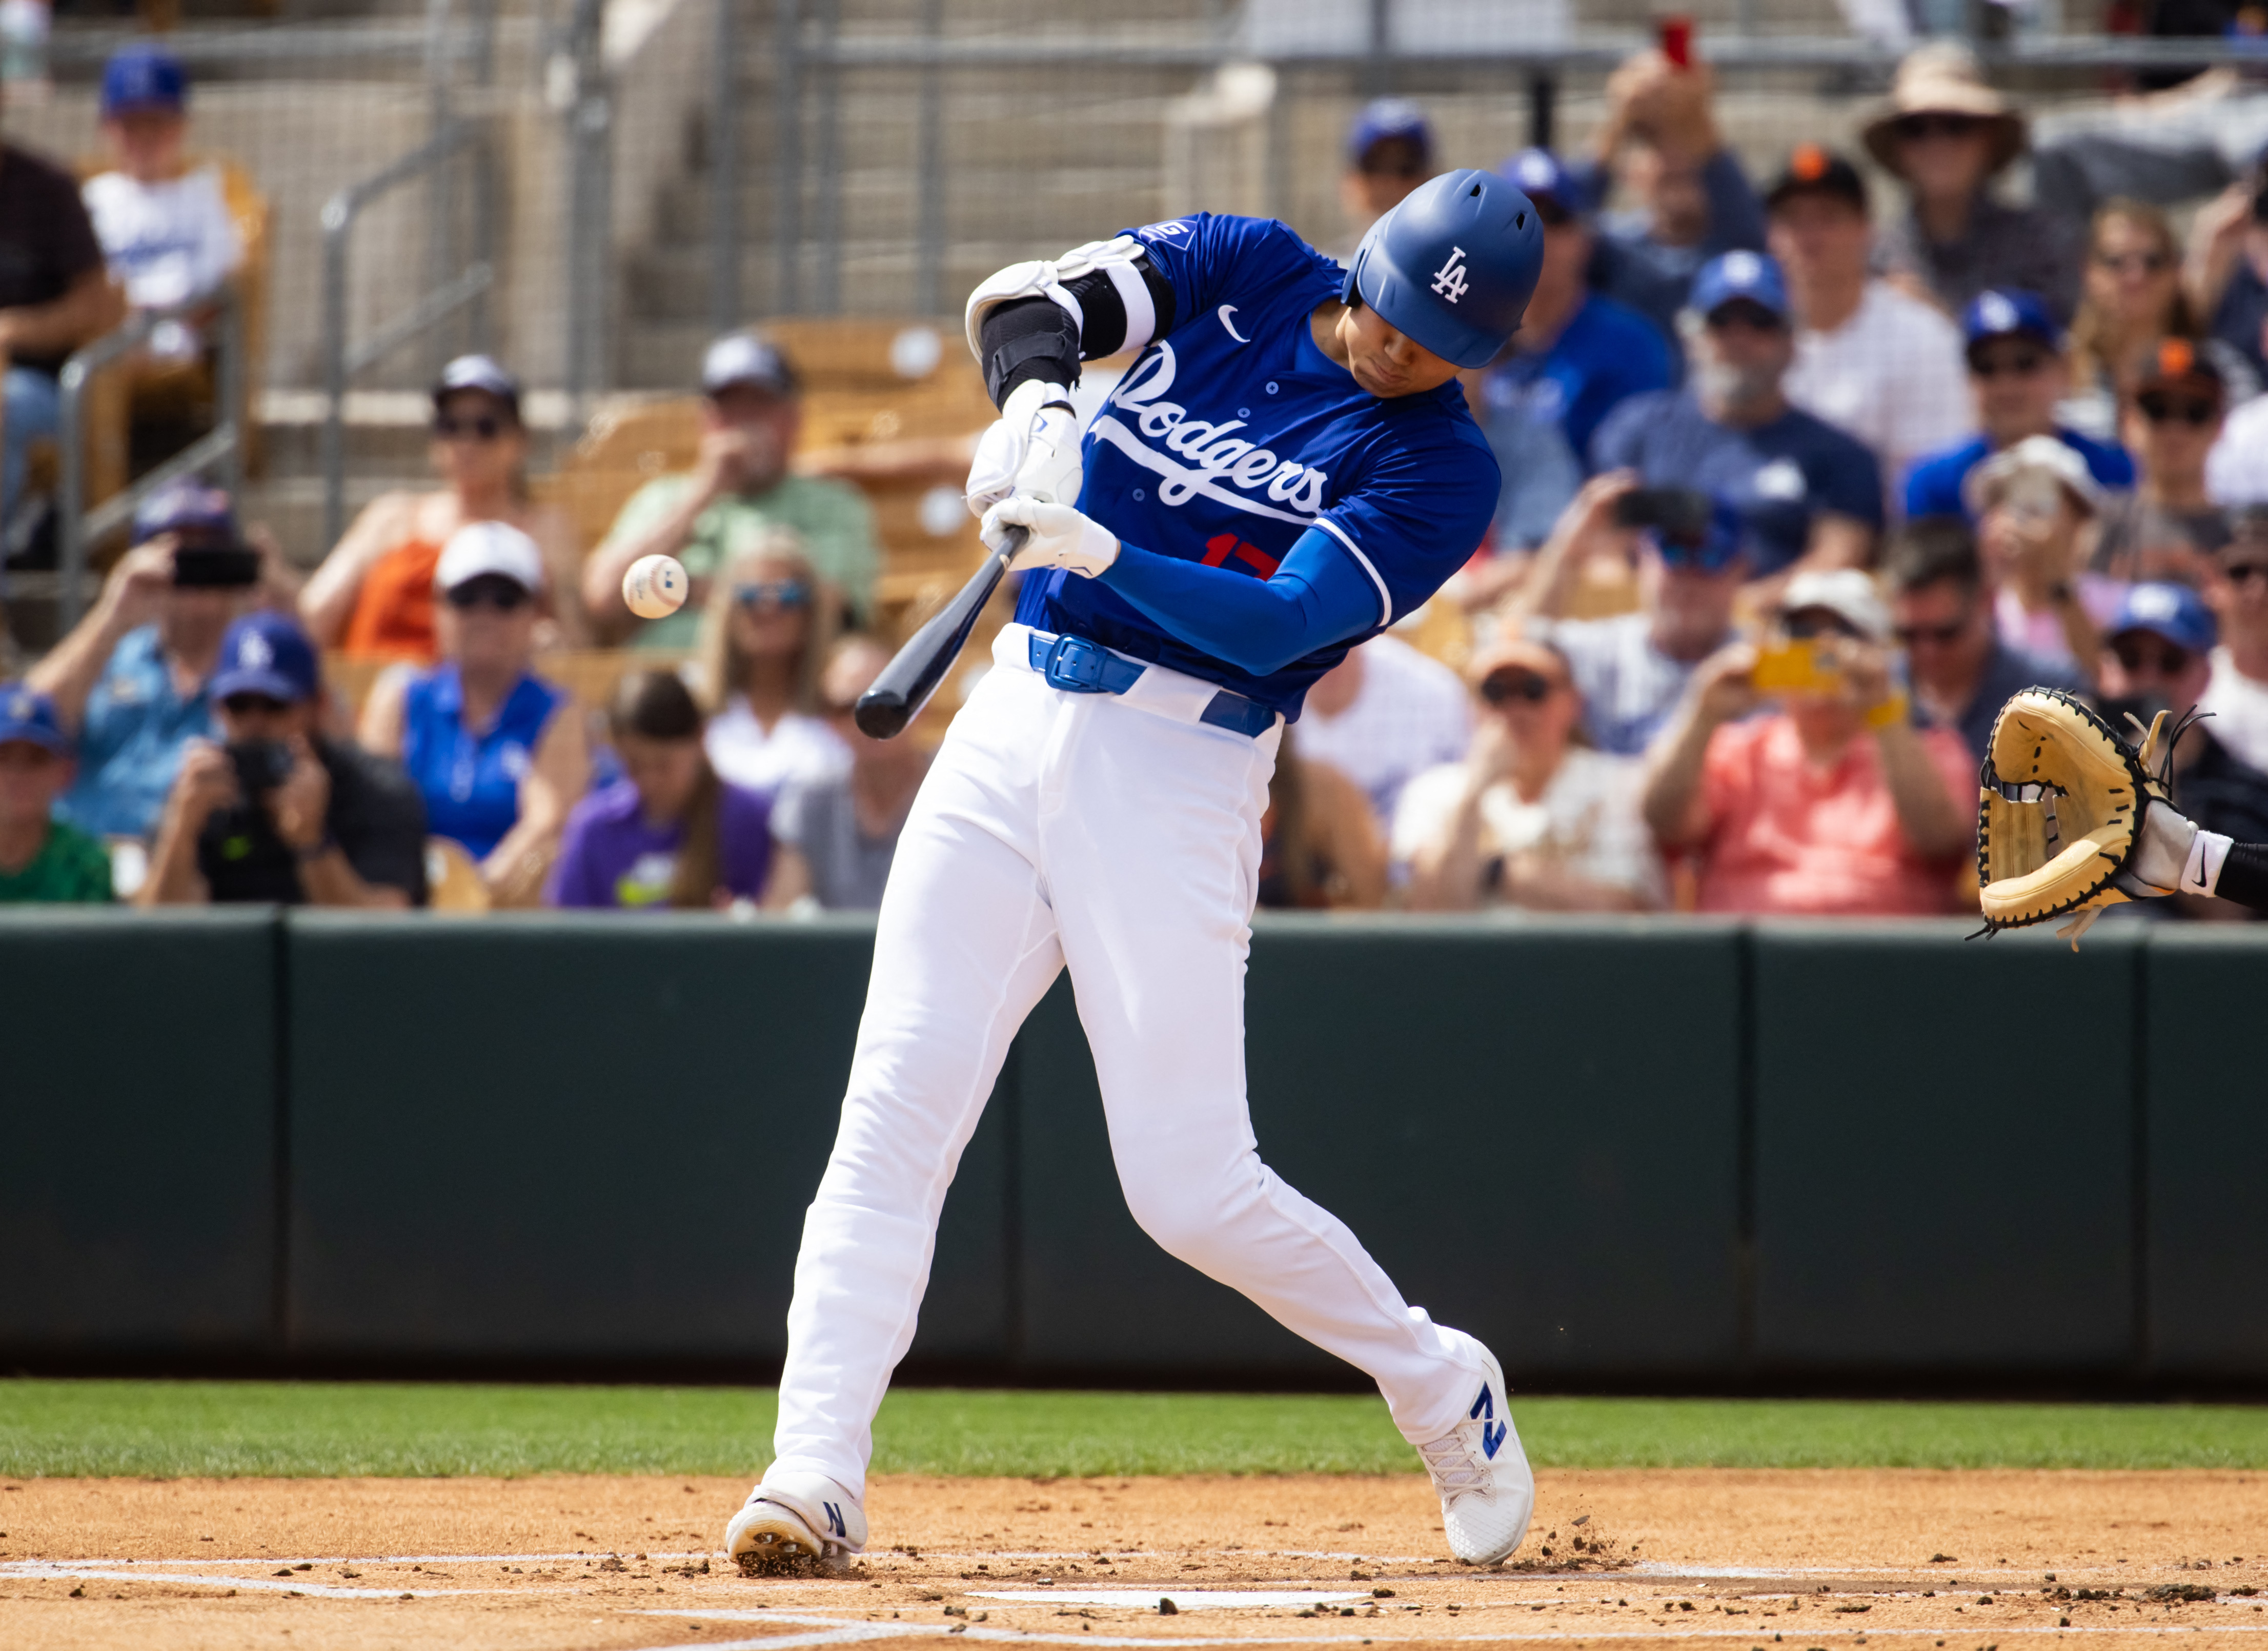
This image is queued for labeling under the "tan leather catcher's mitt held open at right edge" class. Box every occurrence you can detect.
[1978,687,2179,950]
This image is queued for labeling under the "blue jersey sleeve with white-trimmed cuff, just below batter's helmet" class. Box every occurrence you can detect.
[1315,427,1504,628]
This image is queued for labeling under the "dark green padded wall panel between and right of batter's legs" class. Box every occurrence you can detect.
[1018,918,1742,1379]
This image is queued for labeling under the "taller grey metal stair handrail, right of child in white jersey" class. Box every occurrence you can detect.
[322,120,497,547]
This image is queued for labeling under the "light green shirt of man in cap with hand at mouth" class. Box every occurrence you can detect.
[599,472,882,649]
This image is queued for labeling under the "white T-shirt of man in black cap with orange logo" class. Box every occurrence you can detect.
[1785,281,1973,510]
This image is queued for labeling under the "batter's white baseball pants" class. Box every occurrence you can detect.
[774,626,1483,1492]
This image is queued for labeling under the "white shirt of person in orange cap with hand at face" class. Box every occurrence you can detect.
[1392,746,1665,905]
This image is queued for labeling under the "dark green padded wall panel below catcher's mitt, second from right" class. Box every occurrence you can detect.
[1751,923,2141,1377]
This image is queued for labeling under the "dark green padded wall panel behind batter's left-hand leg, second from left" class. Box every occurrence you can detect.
[290,916,1009,1361]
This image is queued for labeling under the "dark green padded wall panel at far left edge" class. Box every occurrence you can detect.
[0,907,279,1356]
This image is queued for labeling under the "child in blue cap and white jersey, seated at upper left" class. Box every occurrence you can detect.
[84,43,245,360]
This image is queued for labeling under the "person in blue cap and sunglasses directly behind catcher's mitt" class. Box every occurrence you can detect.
[2098,585,2268,918]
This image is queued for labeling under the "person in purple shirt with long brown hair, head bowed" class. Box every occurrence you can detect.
[544,671,774,912]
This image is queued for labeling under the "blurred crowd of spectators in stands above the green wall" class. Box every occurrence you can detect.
[0,43,2268,916]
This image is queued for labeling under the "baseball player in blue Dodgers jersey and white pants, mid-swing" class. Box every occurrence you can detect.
[726,172,1542,1563]
